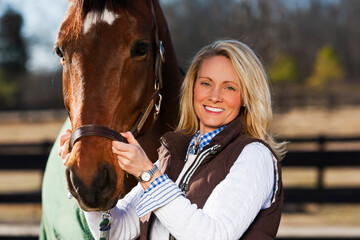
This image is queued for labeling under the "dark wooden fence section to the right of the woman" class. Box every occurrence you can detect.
[282,136,360,204]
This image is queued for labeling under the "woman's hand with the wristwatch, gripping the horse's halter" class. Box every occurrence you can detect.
[112,132,161,189]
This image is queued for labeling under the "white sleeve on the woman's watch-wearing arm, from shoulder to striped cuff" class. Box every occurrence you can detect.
[152,143,274,240]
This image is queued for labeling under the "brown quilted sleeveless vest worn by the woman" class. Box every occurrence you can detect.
[140,118,284,240]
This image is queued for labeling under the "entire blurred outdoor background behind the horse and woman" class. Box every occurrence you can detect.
[0,0,360,239]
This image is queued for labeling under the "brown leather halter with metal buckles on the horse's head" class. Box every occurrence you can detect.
[69,1,165,151]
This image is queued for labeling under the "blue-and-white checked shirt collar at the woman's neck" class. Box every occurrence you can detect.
[185,125,226,161]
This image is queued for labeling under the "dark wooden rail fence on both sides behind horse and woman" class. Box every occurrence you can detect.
[0,137,360,240]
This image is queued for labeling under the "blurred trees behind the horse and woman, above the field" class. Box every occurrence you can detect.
[0,0,360,109]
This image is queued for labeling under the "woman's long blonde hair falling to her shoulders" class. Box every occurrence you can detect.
[176,40,286,159]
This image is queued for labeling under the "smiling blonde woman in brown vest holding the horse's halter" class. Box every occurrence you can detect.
[59,40,285,239]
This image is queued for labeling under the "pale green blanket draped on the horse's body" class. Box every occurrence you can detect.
[39,119,94,240]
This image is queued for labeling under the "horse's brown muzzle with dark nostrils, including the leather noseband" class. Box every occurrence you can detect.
[65,125,126,211]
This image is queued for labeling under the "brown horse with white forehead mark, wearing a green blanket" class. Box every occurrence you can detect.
[40,0,183,239]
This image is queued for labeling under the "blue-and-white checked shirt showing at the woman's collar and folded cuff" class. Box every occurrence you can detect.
[135,125,226,217]
